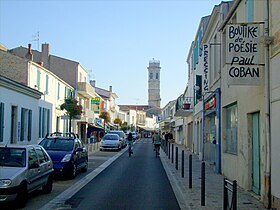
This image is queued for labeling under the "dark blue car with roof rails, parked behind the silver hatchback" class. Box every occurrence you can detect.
[39,132,88,178]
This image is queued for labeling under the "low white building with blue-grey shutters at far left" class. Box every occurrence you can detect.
[0,76,42,144]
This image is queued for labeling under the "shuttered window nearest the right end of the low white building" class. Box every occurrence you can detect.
[20,108,32,141]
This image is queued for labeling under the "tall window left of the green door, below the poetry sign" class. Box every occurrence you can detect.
[226,104,238,154]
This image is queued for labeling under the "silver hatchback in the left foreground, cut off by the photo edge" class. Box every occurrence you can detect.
[0,145,53,208]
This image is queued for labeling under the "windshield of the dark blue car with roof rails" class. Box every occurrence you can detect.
[40,138,74,151]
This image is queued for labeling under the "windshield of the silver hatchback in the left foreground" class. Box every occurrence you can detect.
[0,147,26,167]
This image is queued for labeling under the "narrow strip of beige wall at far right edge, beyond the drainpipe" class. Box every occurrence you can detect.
[270,0,280,205]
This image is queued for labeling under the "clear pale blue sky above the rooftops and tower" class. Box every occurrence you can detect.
[0,0,226,107]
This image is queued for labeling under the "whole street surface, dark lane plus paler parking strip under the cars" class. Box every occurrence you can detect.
[0,139,180,209]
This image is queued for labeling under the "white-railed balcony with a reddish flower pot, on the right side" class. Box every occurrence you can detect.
[175,96,193,117]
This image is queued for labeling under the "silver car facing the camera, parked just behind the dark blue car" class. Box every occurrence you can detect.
[99,133,122,151]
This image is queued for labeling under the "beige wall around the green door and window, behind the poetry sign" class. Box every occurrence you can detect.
[221,1,265,194]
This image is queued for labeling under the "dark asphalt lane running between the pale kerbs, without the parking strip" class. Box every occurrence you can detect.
[61,139,180,210]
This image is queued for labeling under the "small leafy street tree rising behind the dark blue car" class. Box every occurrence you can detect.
[60,97,83,133]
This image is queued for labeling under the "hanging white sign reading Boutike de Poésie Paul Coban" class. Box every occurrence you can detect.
[226,24,260,85]
